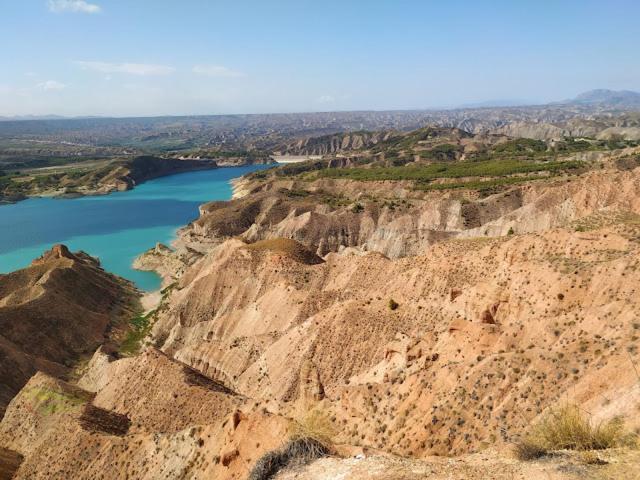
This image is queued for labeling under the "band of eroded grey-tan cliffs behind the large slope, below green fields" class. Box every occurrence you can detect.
[168,166,640,271]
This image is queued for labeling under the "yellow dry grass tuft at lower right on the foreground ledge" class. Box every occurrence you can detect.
[515,405,637,460]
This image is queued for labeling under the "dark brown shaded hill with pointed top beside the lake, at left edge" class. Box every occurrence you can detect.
[0,245,137,411]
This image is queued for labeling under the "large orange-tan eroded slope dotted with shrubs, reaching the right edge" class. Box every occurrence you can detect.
[154,221,640,456]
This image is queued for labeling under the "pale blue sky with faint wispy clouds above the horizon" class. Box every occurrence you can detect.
[0,0,640,116]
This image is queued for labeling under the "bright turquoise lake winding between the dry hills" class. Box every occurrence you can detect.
[0,165,269,291]
